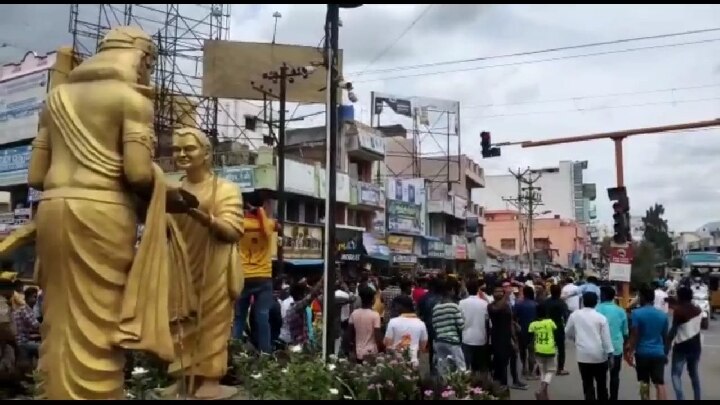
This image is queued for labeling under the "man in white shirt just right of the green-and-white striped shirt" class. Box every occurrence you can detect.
[460,279,490,372]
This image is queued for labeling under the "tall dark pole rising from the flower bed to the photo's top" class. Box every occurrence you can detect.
[322,4,340,361]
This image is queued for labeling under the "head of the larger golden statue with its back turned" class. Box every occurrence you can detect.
[98,26,157,85]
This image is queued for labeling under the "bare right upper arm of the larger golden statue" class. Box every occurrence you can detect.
[123,91,155,190]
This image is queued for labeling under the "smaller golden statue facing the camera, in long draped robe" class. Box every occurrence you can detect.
[170,128,243,399]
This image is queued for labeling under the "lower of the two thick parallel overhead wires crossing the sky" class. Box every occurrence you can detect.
[353,38,720,83]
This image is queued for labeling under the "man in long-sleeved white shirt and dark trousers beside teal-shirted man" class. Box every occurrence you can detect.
[565,292,615,401]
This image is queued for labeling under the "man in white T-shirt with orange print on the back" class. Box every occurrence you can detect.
[383,295,428,364]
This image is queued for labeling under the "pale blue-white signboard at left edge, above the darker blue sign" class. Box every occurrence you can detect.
[0,69,49,144]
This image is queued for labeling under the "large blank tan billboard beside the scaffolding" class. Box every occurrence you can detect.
[202,40,342,103]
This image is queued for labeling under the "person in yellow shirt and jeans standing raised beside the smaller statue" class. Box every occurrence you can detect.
[233,195,277,353]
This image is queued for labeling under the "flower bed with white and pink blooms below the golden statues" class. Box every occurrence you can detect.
[128,344,506,401]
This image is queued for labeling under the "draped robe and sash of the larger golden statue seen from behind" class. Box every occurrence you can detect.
[35,86,195,400]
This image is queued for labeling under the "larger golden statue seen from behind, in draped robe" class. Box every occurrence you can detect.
[24,27,194,400]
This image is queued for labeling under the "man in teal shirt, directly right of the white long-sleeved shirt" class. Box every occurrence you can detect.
[595,286,628,401]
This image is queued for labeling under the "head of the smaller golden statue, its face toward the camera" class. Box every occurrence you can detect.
[172,127,212,171]
